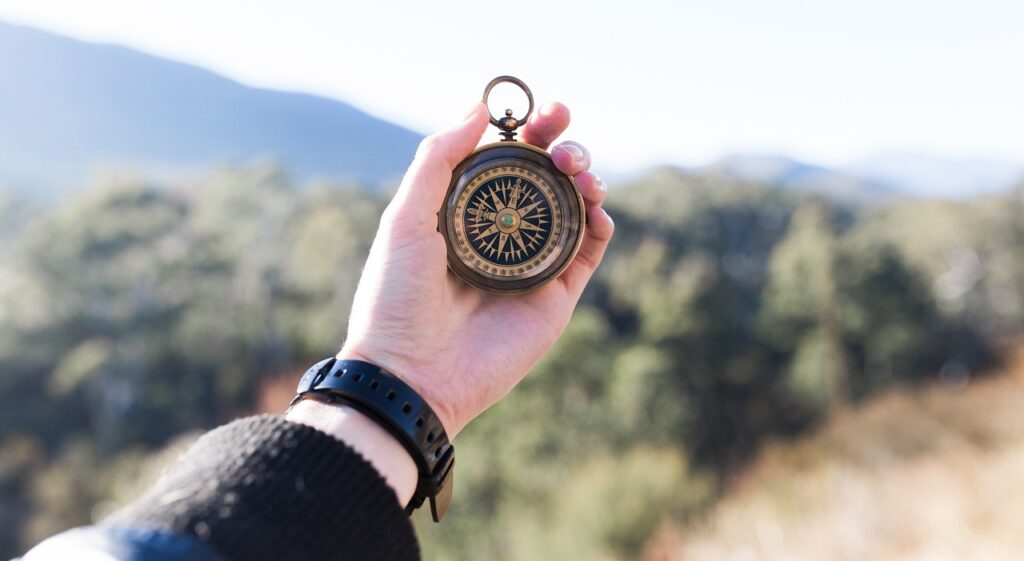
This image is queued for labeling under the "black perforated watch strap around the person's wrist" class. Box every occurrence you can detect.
[292,357,455,522]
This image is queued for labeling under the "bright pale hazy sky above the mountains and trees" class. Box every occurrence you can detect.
[0,0,1024,171]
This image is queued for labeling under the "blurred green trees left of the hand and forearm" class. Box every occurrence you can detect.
[0,168,382,557]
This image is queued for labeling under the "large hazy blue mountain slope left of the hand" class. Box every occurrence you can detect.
[0,23,420,197]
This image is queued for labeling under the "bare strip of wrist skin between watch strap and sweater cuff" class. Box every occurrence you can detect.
[285,399,418,508]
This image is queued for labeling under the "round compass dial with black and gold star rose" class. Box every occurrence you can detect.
[456,167,561,276]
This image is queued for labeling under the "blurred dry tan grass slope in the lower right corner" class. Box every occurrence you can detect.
[645,345,1024,561]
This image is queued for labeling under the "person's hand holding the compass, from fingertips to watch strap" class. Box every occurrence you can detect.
[338,103,614,437]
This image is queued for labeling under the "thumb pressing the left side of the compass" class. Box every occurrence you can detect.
[391,101,489,215]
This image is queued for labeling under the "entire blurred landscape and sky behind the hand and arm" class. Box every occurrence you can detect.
[0,0,1024,561]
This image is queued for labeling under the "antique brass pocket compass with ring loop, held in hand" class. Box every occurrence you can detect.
[437,76,587,294]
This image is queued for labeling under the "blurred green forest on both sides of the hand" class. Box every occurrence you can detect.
[0,167,1024,560]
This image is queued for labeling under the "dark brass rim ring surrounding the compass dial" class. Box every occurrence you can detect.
[437,141,587,294]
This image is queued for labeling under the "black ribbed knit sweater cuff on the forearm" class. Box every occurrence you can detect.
[103,416,419,561]
